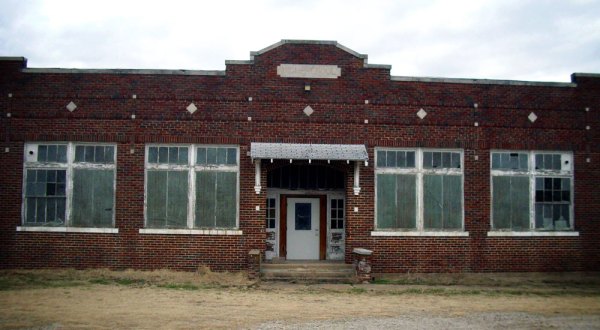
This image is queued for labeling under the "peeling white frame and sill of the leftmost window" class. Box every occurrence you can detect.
[16,141,119,234]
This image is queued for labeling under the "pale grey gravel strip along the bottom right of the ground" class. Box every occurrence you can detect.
[256,313,600,330]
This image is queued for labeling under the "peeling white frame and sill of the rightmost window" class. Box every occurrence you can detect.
[487,149,579,237]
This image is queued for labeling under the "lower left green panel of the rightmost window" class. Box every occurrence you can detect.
[492,176,529,231]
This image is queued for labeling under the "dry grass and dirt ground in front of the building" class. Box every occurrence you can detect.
[0,271,600,329]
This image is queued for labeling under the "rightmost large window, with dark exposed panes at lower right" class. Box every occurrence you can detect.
[491,151,573,231]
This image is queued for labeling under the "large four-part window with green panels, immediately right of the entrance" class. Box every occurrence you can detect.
[375,149,463,231]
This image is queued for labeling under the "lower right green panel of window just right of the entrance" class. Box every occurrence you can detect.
[423,175,463,229]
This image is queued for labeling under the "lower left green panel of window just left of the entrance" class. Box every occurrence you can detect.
[147,171,188,228]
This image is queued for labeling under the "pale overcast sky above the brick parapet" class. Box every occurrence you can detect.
[0,0,600,81]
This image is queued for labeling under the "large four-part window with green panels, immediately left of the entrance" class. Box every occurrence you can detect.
[146,145,239,228]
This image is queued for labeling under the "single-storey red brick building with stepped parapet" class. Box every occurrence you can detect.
[0,40,600,272]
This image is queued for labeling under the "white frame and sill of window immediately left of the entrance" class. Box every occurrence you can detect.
[139,143,242,236]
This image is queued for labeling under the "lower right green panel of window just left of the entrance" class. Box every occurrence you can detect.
[194,171,237,228]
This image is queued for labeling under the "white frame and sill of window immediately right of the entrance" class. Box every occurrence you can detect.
[371,148,469,237]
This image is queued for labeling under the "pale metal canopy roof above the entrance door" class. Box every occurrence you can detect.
[250,142,369,162]
